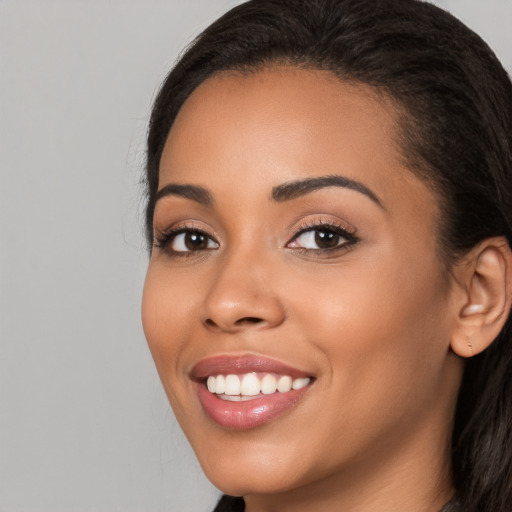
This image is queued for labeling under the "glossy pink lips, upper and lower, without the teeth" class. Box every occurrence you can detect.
[190,355,315,430]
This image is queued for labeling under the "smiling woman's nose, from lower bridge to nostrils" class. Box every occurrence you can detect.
[202,252,285,333]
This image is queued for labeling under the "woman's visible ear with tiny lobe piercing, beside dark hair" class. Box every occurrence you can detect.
[451,237,512,357]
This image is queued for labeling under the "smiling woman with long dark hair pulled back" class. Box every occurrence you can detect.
[143,0,512,512]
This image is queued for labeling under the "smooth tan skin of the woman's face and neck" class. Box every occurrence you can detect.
[143,67,462,512]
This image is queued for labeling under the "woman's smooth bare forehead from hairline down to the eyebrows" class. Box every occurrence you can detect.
[160,67,434,223]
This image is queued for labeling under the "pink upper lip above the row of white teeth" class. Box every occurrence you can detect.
[190,354,312,380]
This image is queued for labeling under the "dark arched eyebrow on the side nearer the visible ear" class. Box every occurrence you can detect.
[272,174,384,209]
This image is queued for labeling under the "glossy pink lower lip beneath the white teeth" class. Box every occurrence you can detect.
[197,383,310,430]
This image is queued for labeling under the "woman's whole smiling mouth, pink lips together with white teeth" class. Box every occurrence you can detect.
[191,356,315,430]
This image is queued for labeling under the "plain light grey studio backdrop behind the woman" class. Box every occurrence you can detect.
[0,0,512,512]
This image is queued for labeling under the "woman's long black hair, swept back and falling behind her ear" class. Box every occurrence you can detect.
[146,0,512,512]
